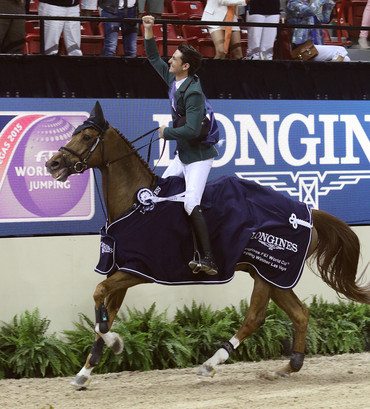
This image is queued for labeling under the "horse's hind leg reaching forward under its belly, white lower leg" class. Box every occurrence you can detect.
[198,274,271,376]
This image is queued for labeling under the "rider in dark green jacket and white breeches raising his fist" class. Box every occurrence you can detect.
[143,16,218,275]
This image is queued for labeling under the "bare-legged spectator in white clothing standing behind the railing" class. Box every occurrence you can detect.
[202,0,245,59]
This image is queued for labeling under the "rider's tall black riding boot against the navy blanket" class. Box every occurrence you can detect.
[189,206,218,275]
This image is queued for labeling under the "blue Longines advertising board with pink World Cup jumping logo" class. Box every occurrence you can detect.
[0,98,370,237]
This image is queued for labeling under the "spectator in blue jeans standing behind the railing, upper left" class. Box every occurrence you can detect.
[99,0,137,58]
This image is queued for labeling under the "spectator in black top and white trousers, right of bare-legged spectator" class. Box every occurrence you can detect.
[246,0,280,60]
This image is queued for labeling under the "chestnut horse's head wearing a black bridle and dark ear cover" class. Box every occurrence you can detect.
[45,102,109,182]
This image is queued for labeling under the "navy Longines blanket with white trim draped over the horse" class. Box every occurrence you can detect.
[95,177,312,289]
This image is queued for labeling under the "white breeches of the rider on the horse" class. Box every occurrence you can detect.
[162,155,214,215]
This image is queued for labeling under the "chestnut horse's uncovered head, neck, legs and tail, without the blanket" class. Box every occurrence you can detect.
[46,102,370,389]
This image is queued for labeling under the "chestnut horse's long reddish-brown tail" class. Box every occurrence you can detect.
[309,209,370,304]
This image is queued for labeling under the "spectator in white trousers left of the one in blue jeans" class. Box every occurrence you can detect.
[39,0,82,56]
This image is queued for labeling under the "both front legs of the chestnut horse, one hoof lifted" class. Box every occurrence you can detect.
[71,271,144,388]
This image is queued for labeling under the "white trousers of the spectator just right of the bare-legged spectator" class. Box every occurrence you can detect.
[247,14,280,60]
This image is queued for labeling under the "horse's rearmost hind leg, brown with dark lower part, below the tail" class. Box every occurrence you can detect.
[271,288,310,377]
